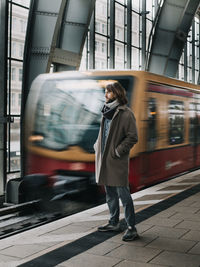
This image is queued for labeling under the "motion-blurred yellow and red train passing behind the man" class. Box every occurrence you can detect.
[25,70,200,201]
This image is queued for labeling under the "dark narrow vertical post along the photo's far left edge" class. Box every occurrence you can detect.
[0,0,8,195]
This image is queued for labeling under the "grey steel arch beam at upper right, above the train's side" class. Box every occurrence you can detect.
[147,0,199,77]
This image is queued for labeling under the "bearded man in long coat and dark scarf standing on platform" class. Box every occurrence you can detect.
[94,81,138,241]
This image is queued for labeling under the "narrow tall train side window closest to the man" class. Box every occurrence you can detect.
[147,98,157,150]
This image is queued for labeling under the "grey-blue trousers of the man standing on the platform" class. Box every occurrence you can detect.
[105,186,135,228]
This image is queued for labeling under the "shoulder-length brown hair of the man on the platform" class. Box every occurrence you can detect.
[106,82,128,105]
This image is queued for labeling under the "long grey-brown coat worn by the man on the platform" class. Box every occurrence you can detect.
[94,105,138,186]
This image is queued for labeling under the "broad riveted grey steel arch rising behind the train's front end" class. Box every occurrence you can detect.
[22,0,95,105]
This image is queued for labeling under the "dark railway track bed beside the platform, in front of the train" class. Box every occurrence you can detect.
[0,200,102,239]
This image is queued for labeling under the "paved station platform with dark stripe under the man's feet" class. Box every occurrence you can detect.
[0,170,200,267]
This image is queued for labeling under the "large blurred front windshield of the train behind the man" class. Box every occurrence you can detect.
[33,76,133,153]
